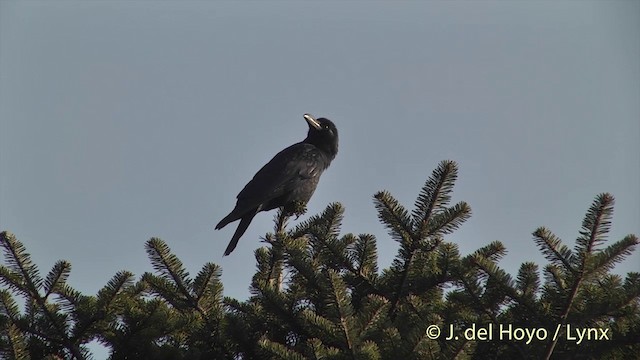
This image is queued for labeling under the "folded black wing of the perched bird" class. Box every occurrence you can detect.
[234,143,326,214]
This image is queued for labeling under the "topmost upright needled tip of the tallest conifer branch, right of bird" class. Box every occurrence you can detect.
[413,160,458,224]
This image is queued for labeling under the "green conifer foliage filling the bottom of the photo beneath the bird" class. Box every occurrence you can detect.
[0,161,640,360]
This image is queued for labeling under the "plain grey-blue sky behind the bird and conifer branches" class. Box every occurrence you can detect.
[0,1,640,346]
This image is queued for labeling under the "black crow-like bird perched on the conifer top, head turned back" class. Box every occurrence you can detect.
[216,114,338,256]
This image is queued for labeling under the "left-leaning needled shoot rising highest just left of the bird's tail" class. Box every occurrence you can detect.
[145,238,195,303]
